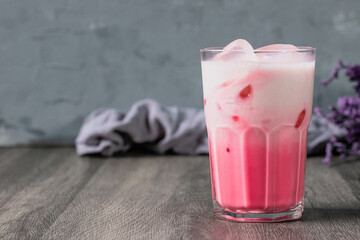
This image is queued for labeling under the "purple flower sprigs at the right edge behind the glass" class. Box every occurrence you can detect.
[314,61,360,164]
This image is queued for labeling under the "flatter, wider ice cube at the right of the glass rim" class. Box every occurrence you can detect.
[255,44,306,63]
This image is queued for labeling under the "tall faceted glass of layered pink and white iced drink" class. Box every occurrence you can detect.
[201,39,315,222]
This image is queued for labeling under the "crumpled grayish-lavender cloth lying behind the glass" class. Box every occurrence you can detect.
[75,99,345,156]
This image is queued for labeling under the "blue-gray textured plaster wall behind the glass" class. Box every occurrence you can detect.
[0,0,360,145]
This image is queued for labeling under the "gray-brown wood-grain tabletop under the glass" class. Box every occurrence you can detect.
[0,148,360,239]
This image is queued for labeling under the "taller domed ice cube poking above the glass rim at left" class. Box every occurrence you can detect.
[214,39,257,62]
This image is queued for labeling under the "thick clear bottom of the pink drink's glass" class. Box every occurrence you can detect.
[213,200,304,222]
